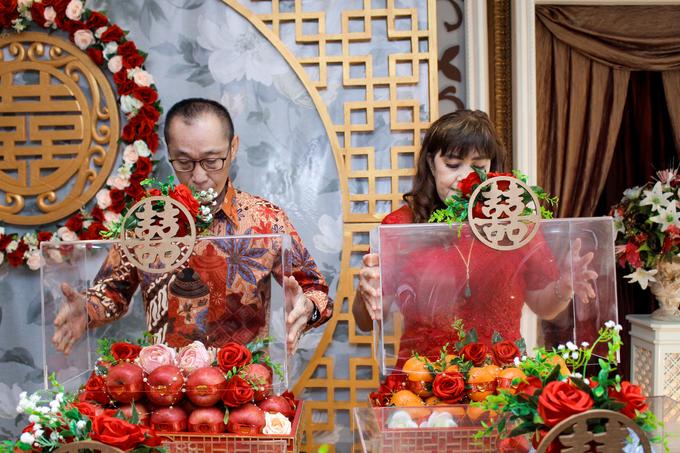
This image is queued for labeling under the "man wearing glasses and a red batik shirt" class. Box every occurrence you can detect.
[52,99,333,354]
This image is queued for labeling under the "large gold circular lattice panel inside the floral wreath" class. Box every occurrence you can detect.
[0,32,120,225]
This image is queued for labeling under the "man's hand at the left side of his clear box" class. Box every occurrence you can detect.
[52,283,87,355]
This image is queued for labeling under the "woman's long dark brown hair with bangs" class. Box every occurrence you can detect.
[404,110,506,223]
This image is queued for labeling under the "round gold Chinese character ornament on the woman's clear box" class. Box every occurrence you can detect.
[468,176,541,250]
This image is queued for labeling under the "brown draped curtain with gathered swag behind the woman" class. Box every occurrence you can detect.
[536,5,680,217]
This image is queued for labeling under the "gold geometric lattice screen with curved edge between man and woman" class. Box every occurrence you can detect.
[223,0,438,452]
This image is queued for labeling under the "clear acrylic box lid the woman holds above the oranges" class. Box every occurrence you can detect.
[370,217,617,375]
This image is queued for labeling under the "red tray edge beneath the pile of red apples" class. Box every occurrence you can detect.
[157,400,305,453]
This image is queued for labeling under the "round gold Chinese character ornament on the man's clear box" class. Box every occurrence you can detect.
[120,197,196,274]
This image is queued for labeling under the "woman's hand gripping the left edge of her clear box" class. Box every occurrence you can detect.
[352,253,382,332]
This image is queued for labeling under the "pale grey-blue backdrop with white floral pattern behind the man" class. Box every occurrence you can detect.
[0,0,464,451]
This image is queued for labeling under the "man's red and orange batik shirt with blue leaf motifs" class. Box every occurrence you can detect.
[87,181,333,347]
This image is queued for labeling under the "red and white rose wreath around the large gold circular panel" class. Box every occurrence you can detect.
[0,0,163,270]
